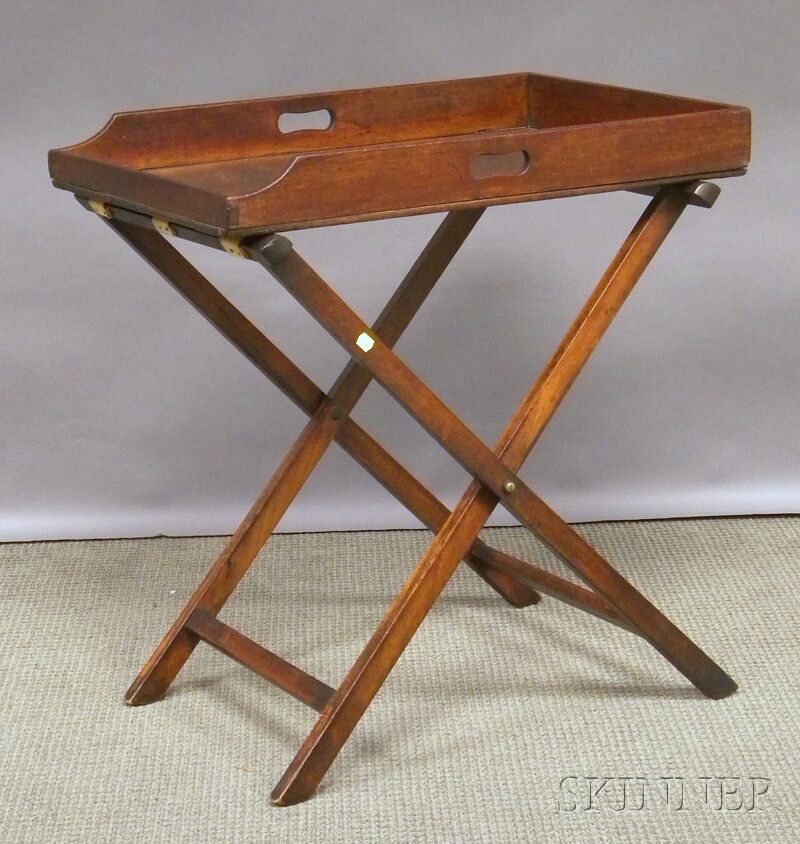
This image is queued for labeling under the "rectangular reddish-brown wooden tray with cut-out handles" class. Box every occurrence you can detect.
[49,73,750,234]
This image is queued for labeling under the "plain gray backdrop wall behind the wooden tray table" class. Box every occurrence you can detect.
[0,0,800,540]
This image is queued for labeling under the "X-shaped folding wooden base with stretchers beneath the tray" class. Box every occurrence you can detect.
[81,182,736,805]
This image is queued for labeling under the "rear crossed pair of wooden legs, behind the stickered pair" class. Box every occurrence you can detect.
[107,209,539,705]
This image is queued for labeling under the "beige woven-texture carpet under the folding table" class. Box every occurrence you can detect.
[0,518,800,844]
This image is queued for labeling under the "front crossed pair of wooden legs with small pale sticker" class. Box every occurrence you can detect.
[260,189,736,805]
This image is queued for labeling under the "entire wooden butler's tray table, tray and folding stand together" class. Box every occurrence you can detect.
[50,74,749,805]
